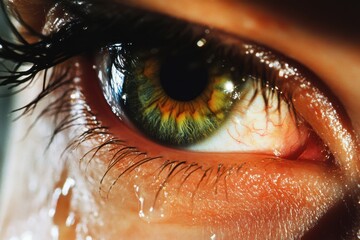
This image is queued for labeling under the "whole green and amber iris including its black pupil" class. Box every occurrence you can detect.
[118,46,248,146]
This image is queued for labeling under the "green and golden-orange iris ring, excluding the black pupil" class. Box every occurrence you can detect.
[127,58,242,145]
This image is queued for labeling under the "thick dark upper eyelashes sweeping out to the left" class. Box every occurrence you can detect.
[0,1,296,115]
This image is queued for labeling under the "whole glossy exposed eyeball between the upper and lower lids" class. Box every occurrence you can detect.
[97,25,326,158]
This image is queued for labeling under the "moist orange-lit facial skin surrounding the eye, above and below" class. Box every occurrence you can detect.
[0,0,360,239]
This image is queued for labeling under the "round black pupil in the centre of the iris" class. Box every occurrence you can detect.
[160,54,209,102]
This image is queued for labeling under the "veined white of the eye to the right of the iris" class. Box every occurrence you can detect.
[187,85,304,156]
